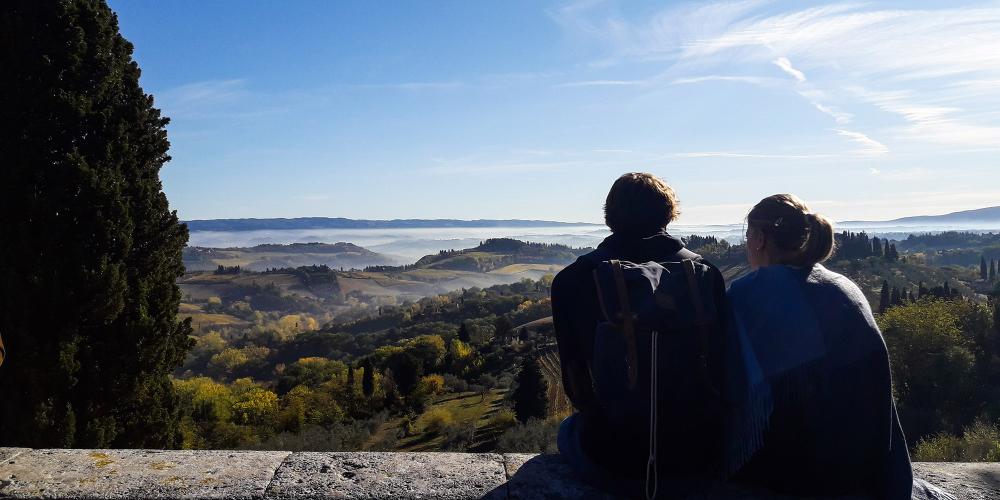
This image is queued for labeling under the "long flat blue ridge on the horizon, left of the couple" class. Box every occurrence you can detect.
[185,217,596,231]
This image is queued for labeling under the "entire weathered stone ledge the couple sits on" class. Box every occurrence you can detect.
[0,448,1000,500]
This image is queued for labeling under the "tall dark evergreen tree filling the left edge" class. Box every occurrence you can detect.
[0,0,191,448]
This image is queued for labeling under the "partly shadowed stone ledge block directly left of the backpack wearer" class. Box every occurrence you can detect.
[503,453,615,500]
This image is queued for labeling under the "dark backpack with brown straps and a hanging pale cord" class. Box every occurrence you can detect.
[586,249,724,498]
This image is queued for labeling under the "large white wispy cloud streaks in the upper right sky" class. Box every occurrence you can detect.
[556,0,1000,148]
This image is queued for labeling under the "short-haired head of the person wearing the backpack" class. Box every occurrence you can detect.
[604,172,680,237]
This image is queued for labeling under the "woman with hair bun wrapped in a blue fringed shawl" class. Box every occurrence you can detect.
[729,194,920,499]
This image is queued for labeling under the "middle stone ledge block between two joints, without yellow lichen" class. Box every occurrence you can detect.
[267,452,506,499]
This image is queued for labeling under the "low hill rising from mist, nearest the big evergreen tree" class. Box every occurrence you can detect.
[184,243,401,271]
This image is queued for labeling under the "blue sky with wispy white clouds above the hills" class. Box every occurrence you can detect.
[109,0,1000,224]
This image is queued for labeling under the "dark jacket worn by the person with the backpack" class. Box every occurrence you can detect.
[552,232,726,477]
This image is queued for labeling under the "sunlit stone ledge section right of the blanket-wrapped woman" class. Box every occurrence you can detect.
[913,462,1000,500]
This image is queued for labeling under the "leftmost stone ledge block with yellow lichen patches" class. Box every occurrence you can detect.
[0,450,288,499]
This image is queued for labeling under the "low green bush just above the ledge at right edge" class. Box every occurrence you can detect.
[913,420,1000,462]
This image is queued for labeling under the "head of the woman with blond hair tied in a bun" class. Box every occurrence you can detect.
[747,194,834,267]
